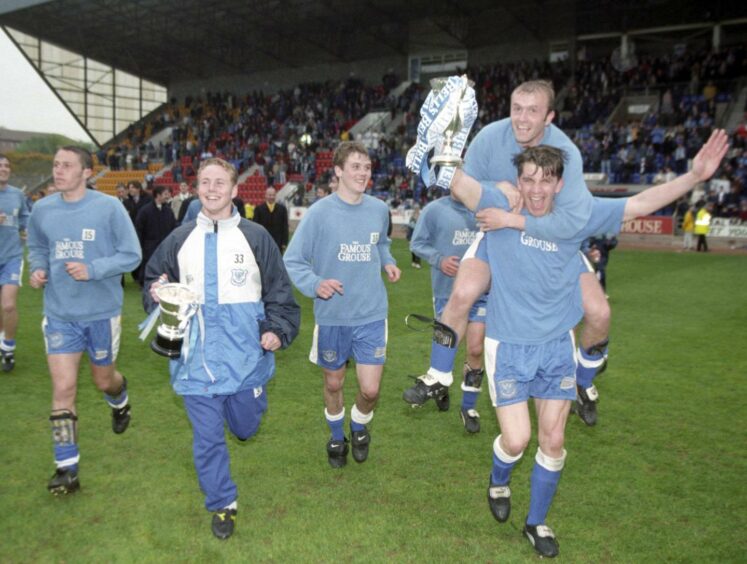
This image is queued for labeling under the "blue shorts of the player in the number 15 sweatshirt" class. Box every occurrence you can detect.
[42,315,122,366]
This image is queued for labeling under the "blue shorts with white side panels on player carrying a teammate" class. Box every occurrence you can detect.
[485,331,576,407]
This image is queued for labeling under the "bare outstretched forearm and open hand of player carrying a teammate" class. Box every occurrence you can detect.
[623,129,729,221]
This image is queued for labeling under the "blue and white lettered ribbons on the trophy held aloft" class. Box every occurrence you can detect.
[406,75,477,189]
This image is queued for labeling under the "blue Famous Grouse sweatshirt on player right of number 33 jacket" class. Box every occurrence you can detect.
[283,194,395,326]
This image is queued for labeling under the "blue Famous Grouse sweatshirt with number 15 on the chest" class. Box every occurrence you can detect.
[28,190,141,321]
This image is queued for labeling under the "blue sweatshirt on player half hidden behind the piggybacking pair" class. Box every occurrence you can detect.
[410,196,478,299]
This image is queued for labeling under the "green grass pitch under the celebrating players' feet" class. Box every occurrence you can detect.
[0,241,747,562]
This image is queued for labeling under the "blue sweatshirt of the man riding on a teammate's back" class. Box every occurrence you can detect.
[464,118,592,241]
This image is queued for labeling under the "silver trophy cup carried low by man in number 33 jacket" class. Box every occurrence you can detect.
[150,283,200,358]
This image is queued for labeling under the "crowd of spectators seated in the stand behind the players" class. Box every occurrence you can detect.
[99,45,747,220]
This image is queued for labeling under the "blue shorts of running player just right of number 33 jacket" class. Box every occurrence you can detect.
[309,319,387,370]
